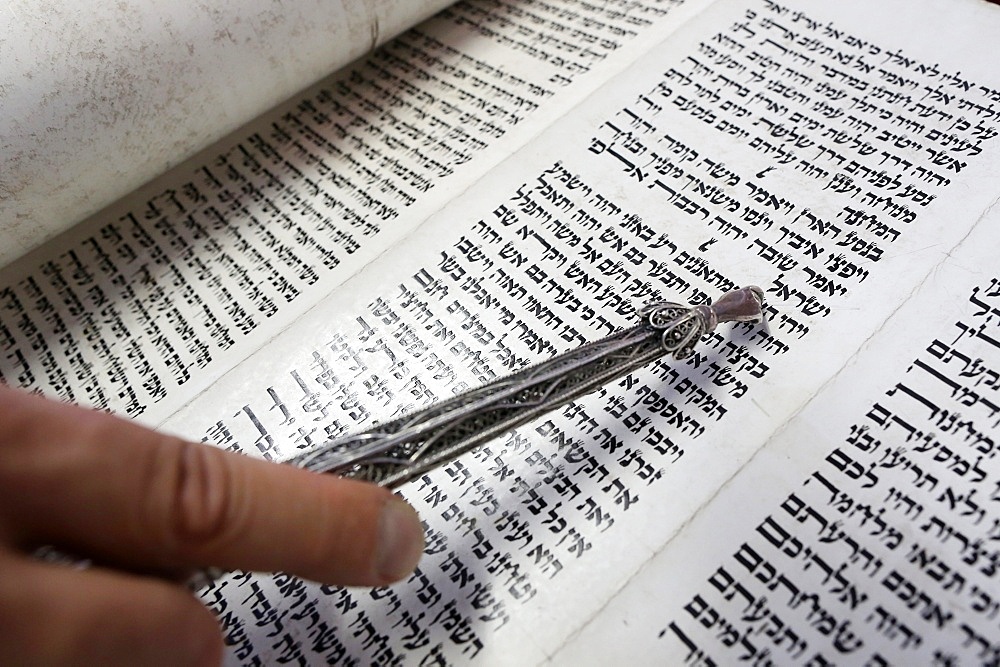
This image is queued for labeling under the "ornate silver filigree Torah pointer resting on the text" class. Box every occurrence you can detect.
[288,287,764,487]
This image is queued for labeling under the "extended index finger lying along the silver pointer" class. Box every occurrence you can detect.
[0,389,423,585]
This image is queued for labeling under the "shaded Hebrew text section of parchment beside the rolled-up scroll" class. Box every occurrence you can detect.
[0,0,712,425]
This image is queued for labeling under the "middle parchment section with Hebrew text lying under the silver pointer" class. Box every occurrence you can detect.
[150,2,1000,664]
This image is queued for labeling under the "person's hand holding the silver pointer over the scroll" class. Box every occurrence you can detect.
[0,385,423,665]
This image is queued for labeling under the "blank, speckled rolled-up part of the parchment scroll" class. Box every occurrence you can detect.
[0,0,449,266]
